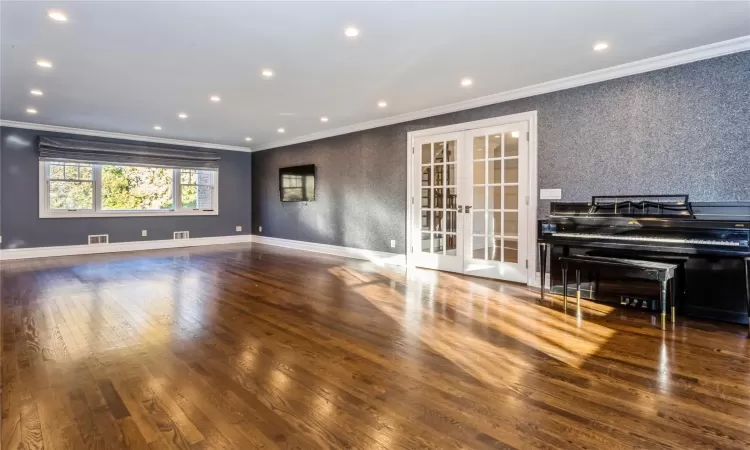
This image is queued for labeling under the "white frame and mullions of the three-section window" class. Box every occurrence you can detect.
[39,160,219,219]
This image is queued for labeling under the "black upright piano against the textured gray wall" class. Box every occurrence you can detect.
[537,195,750,323]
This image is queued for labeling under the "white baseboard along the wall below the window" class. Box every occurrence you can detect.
[0,234,251,261]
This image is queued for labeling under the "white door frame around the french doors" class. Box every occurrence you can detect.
[406,111,539,286]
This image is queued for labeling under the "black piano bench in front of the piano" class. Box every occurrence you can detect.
[556,255,678,330]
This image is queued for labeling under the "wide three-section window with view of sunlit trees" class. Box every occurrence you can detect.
[39,161,218,218]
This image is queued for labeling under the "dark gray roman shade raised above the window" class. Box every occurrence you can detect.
[39,137,220,169]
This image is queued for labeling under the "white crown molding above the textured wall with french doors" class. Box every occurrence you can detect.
[252,35,750,152]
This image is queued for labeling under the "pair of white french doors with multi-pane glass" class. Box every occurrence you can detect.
[412,122,529,283]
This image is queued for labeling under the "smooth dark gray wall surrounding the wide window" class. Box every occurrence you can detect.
[0,127,252,249]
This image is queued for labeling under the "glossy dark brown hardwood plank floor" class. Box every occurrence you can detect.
[1,245,750,450]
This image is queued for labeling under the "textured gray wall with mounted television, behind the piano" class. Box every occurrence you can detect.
[252,52,750,253]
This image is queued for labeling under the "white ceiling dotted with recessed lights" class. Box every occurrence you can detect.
[0,1,750,151]
